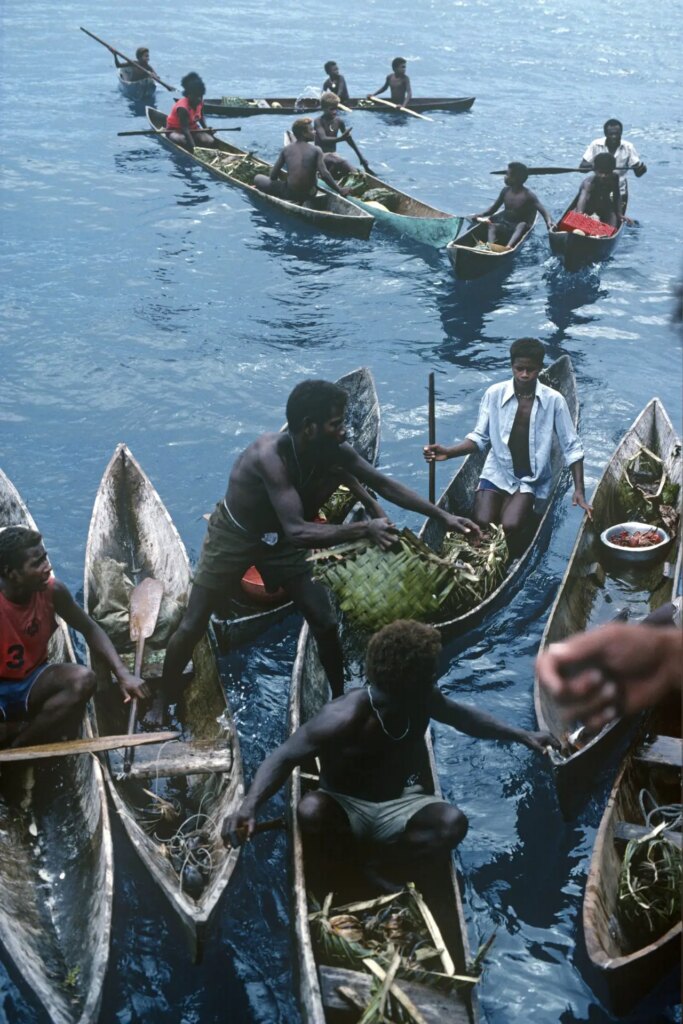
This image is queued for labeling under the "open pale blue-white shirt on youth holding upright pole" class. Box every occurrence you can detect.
[467,379,584,499]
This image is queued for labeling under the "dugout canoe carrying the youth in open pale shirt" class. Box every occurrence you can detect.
[419,355,579,638]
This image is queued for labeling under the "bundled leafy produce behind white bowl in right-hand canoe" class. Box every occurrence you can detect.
[618,445,681,537]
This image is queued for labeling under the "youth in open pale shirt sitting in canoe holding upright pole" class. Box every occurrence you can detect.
[424,338,593,557]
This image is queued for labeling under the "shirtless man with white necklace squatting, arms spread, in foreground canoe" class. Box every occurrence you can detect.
[222,621,555,891]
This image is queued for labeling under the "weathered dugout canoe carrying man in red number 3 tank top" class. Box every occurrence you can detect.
[0,470,114,1024]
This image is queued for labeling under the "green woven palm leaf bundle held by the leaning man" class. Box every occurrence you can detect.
[309,529,455,632]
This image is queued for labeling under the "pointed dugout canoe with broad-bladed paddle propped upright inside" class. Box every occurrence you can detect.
[84,444,244,958]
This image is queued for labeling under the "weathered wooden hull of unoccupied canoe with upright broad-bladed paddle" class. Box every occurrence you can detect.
[84,444,244,957]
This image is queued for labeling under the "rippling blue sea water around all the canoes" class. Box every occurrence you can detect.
[0,0,683,1024]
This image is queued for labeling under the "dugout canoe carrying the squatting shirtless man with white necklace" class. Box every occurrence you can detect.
[288,623,478,1024]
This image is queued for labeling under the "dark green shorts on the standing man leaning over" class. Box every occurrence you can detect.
[195,502,310,593]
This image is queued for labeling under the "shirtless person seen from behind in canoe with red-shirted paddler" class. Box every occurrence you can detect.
[254,118,349,203]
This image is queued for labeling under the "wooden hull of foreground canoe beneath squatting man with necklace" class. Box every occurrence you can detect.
[288,623,478,1024]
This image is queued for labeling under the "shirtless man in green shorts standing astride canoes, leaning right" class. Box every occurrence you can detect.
[163,381,479,696]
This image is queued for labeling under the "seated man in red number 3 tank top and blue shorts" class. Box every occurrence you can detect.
[0,526,147,746]
